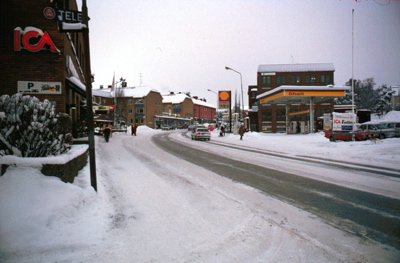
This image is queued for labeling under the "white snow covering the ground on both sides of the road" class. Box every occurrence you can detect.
[0,112,400,262]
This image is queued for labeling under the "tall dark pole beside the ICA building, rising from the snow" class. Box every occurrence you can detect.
[82,0,97,192]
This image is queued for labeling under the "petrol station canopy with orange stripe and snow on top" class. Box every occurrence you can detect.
[257,85,351,104]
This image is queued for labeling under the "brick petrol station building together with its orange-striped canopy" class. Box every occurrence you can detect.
[255,63,349,133]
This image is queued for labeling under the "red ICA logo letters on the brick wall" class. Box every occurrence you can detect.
[14,27,60,53]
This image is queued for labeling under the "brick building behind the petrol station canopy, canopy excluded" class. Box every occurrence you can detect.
[255,63,335,133]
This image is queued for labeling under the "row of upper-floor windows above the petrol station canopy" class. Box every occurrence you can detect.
[261,74,332,87]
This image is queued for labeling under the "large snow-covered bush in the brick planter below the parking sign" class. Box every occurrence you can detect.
[0,94,72,157]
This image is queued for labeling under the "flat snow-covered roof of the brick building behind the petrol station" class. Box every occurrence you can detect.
[257,63,335,72]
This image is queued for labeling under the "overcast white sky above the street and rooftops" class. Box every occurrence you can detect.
[83,0,400,107]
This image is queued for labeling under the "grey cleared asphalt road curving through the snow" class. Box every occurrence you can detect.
[152,134,400,249]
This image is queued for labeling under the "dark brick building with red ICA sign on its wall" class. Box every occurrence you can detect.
[0,0,91,135]
